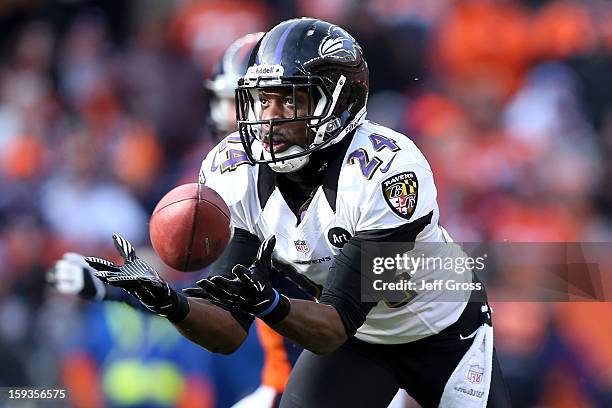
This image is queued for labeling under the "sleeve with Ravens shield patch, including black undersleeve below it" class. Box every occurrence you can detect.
[320,127,439,336]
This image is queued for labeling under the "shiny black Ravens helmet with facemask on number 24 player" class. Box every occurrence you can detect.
[236,18,369,172]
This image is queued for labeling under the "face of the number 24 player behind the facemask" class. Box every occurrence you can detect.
[258,88,314,153]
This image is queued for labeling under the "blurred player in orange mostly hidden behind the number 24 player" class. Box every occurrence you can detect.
[47,33,403,408]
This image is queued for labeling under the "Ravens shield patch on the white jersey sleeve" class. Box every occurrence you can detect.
[382,171,419,220]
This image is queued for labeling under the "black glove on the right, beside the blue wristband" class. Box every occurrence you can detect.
[183,236,291,324]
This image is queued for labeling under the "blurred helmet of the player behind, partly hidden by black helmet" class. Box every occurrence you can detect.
[205,33,264,139]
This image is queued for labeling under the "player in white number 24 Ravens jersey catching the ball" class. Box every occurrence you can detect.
[82,18,509,407]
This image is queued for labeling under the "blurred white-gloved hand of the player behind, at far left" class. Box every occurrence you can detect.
[46,252,106,300]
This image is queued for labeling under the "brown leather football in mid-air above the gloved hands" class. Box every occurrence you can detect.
[149,183,231,272]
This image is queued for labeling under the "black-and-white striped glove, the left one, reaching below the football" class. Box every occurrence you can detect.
[85,234,189,322]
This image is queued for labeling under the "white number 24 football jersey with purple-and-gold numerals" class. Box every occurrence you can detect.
[199,121,472,344]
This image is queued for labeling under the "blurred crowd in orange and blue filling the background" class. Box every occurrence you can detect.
[0,0,612,407]
